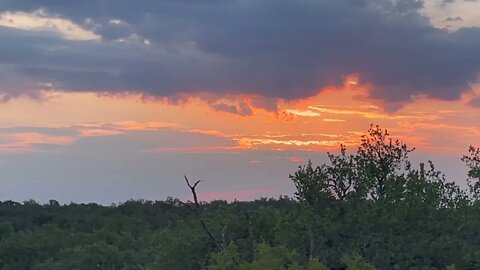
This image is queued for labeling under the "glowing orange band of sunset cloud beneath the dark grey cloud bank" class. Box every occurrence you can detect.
[0,77,480,157]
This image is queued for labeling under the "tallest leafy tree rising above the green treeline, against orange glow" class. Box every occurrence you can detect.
[290,126,414,204]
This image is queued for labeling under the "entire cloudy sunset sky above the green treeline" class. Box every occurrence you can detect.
[0,0,480,202]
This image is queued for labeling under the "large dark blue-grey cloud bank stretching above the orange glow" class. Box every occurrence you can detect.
[0,0,480,103]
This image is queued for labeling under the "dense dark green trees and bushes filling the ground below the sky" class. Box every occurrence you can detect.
[0,127,480,270]
